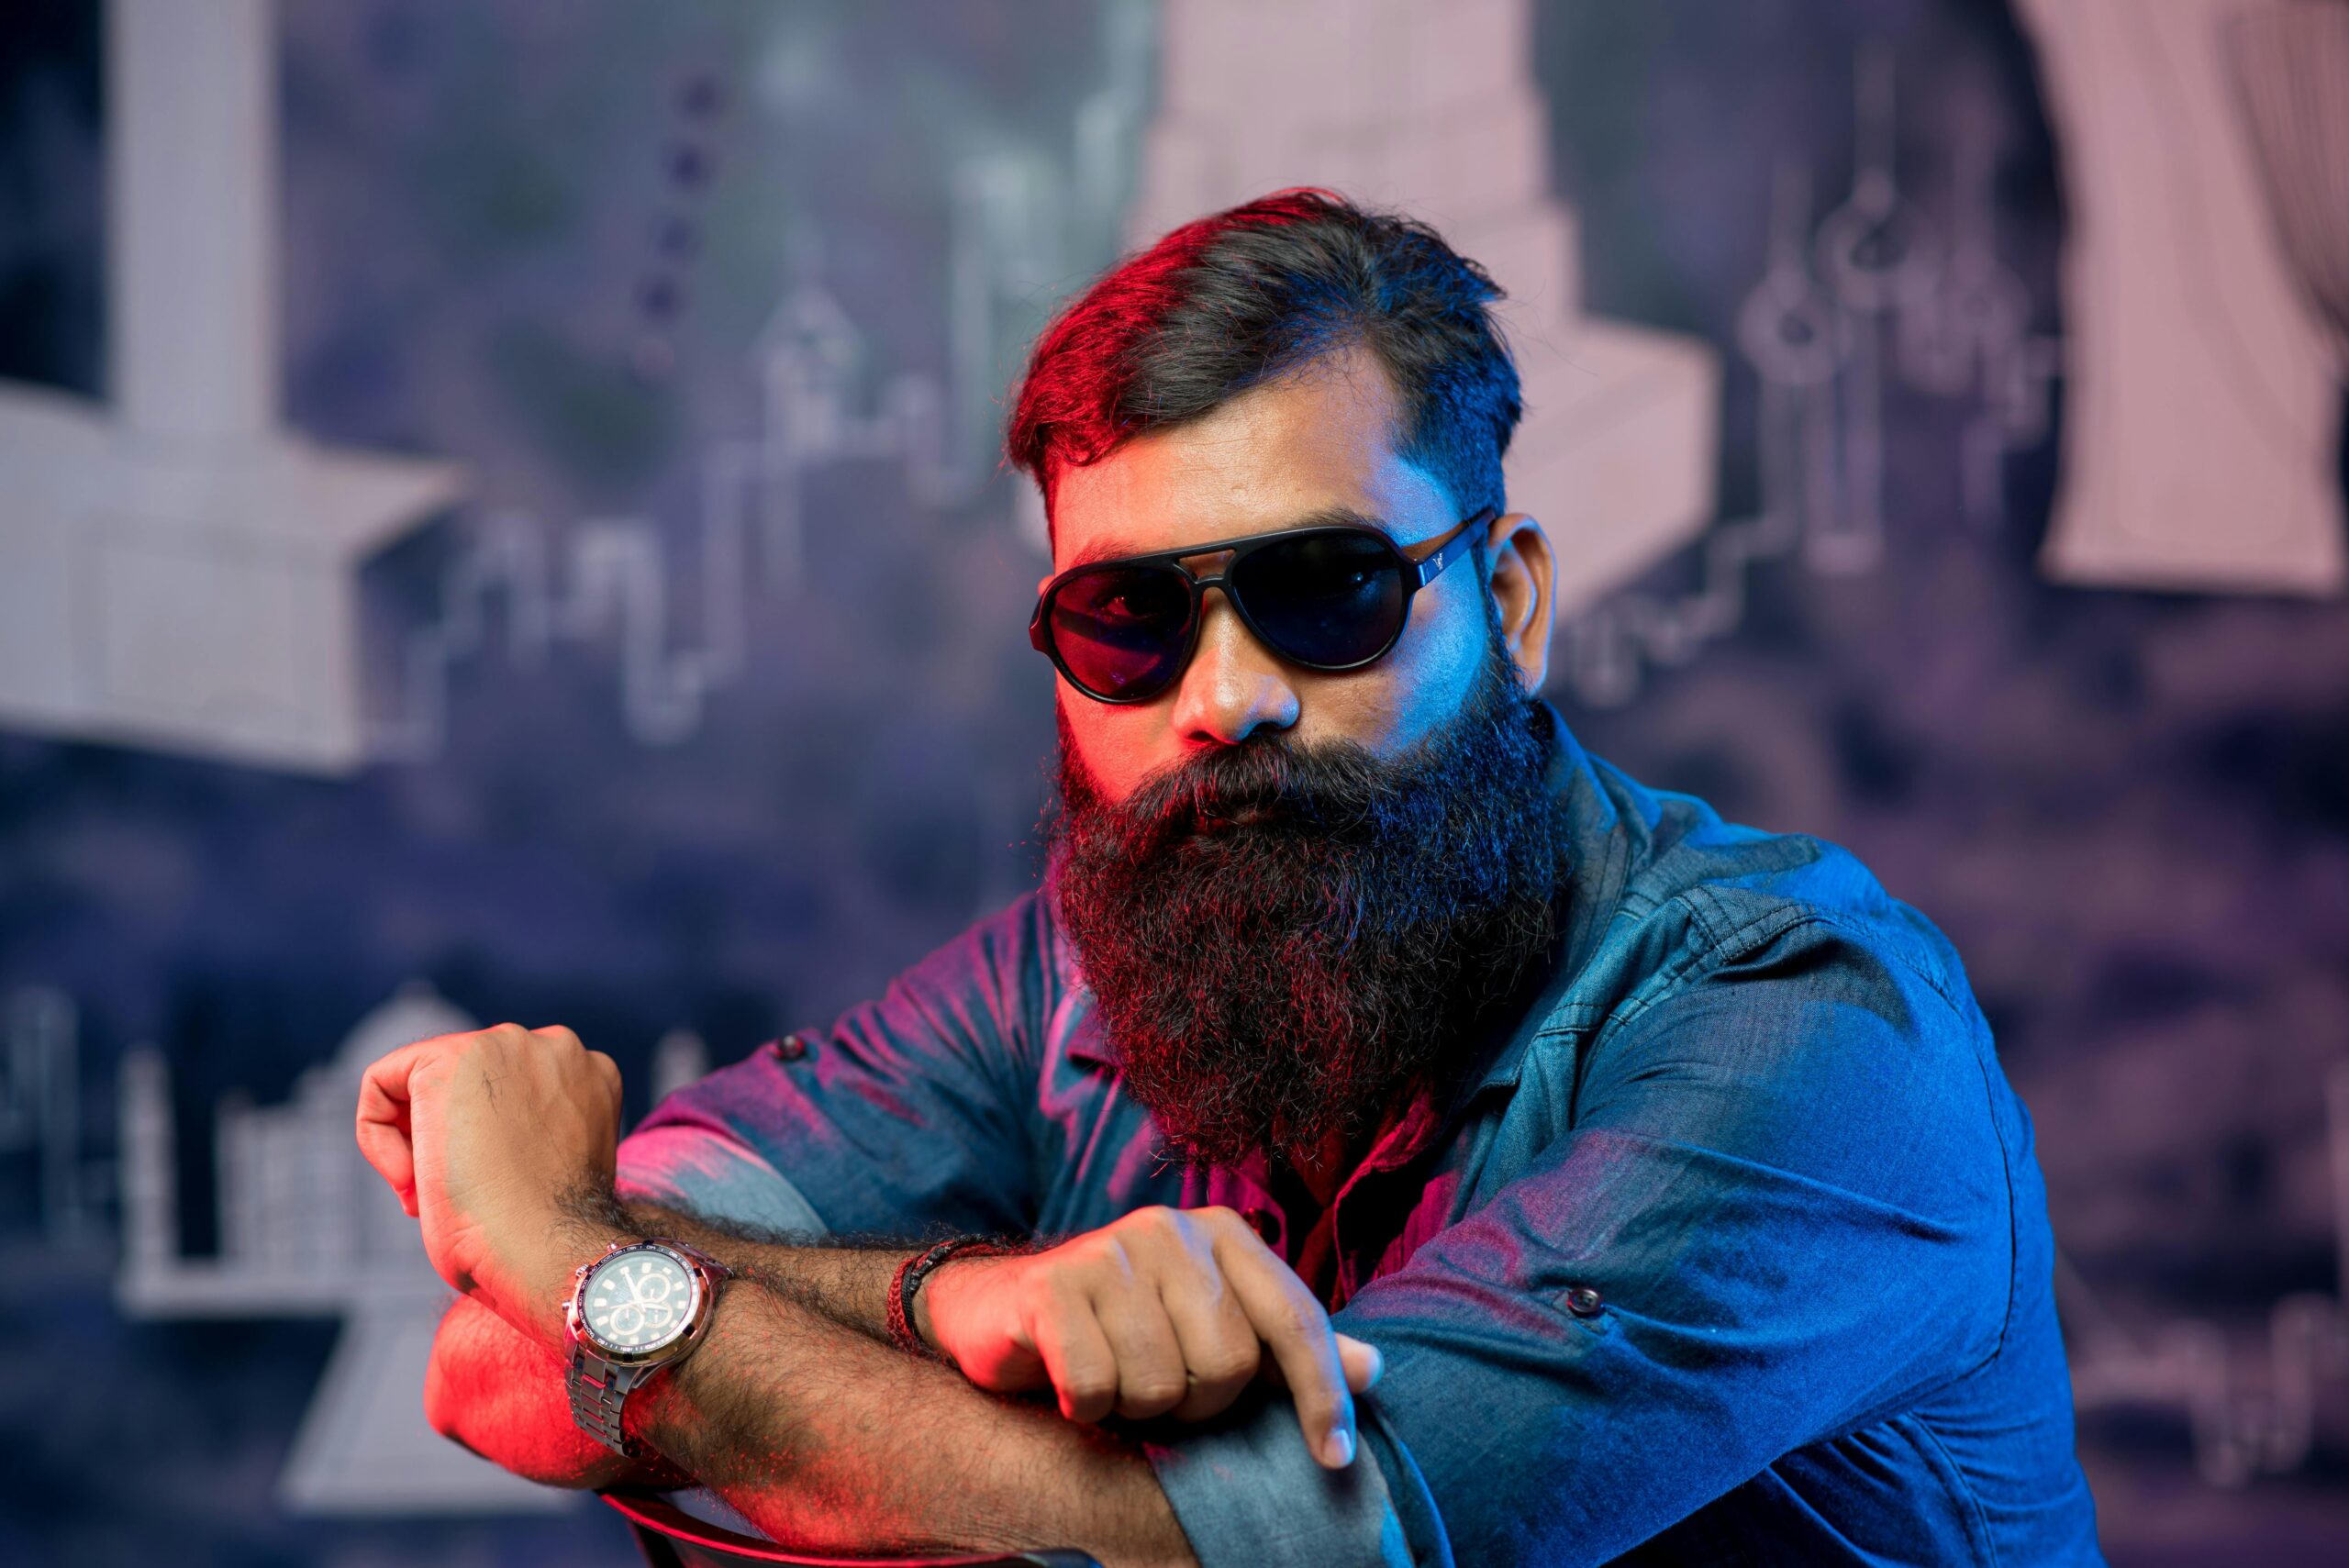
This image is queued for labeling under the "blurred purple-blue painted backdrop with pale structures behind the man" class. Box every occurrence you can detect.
[0,0,2349,1568]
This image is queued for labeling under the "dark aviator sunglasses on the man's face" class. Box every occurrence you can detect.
[1029,507,1498,702]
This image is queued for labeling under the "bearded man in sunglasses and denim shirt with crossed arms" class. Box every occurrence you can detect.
[360,190,2100,1568]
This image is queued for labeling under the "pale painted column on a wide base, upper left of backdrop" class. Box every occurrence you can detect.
[0,0,458,773]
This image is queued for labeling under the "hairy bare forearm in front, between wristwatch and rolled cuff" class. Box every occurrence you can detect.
[639,1282,1196,1568]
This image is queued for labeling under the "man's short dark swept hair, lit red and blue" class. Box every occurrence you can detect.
[1006,188,1524,539]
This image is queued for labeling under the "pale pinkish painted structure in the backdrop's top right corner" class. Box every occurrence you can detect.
[2018,0,2349,594]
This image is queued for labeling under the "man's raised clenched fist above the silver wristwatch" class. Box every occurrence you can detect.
[360,1023,620,1342]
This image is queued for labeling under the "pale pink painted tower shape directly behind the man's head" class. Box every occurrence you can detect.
[1128,0,1721,625]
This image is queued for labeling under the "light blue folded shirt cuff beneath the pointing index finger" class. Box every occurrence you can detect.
[1141,1385,1419,1568]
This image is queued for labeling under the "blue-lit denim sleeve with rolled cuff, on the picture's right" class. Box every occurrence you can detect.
[1153,928,2013,1568]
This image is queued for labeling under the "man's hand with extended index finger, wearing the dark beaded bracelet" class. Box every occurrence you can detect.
[914,1207,1379,1470]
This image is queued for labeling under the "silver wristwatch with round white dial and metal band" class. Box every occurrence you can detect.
[563,1241,733,1460]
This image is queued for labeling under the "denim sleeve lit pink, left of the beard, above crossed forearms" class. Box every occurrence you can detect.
[620,899,1048,1237]
